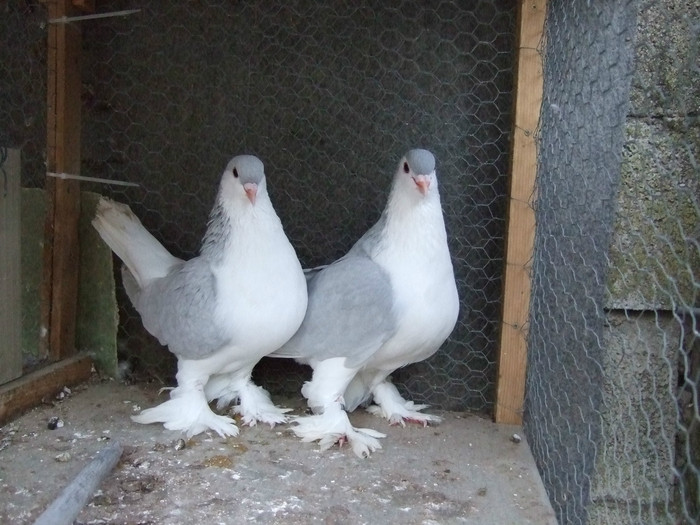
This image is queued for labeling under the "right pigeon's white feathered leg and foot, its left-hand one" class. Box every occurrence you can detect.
[292,358,386,457]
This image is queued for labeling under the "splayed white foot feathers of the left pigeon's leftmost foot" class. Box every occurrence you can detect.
[131,380,238,438]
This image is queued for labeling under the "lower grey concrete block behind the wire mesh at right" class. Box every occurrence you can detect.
[589,311,681,525]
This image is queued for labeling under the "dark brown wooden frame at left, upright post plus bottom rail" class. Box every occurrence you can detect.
[0,0,93,425]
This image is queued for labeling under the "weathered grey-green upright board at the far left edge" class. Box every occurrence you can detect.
[0,148,22,384]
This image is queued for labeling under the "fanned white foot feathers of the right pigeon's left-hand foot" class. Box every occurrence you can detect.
[292,402,386,458]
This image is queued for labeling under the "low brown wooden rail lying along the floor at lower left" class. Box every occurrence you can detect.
[0,354,92,425]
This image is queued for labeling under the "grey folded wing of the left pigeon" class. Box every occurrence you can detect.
[130,258,231,359]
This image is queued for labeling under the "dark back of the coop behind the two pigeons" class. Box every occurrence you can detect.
[4,1,515,411]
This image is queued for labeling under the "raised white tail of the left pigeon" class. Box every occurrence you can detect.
[92,197,180,288]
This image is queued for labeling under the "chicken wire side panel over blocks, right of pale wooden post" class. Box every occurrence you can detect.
[525,0,700,524]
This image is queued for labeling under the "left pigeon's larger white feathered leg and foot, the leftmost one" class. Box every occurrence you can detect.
[131,359,238,437]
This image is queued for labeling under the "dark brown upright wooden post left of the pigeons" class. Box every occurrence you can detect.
[40,0,81,361]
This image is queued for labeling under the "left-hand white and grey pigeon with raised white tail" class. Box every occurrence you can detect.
[93,155,308,436]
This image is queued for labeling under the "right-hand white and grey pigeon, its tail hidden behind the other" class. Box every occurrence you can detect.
[272,149,459,456]
